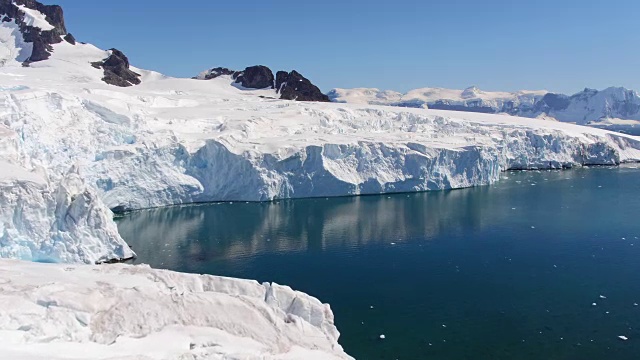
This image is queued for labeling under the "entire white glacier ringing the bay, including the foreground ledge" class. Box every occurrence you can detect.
[0,0,640,360]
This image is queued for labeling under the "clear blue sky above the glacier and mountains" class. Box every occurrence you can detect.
[56,0,640,93]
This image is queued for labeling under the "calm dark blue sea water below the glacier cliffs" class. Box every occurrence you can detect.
[119,168,640,359]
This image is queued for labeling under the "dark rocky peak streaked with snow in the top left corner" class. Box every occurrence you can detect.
[0,0,67,64]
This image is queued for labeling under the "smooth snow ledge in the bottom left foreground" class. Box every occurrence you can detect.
[0,260,350,360]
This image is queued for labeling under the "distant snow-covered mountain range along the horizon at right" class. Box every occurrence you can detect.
[328,87,640,124]
